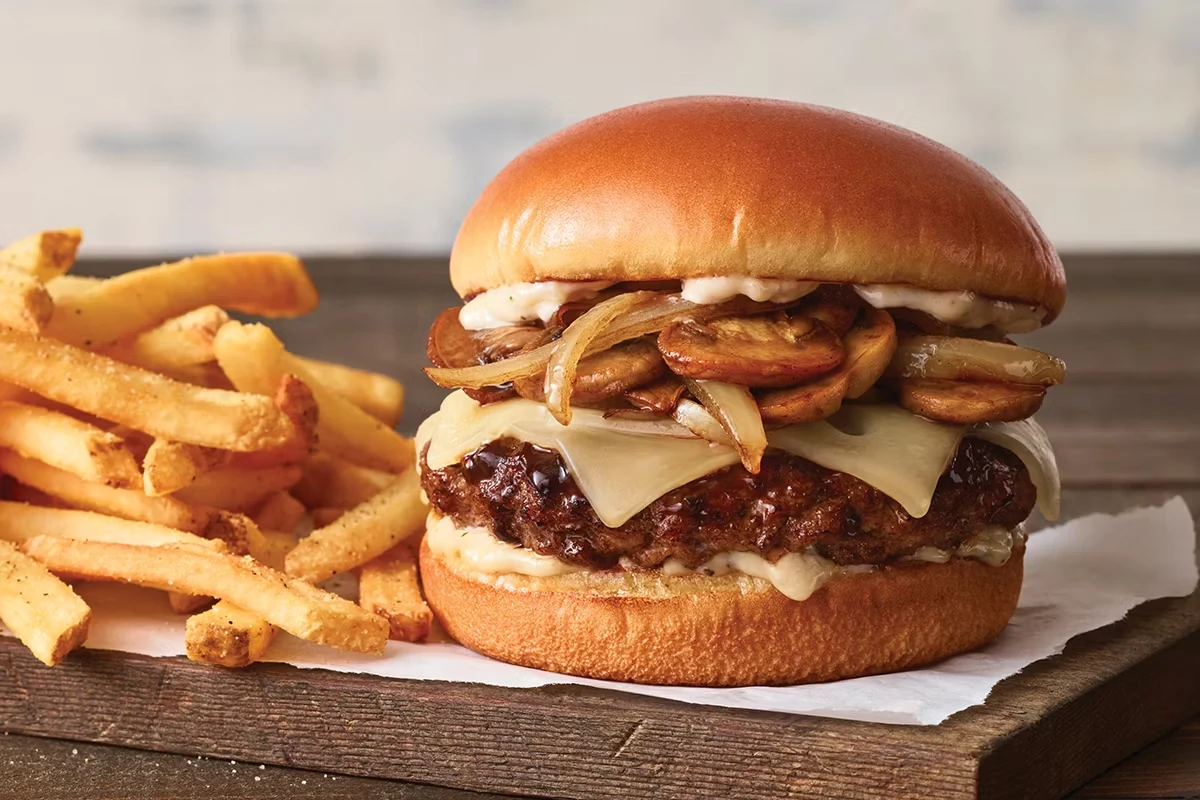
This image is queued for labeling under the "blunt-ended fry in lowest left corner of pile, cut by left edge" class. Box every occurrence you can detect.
[0,542,91,667]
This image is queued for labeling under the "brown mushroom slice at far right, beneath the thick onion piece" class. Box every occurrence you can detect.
[896,379,1046,425]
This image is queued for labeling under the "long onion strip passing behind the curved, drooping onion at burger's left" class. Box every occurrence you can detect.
[425,291,801,389]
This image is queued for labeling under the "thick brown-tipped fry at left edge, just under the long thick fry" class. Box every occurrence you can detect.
[0,402,142,488]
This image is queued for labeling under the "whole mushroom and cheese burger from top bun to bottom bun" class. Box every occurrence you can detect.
[418,97,1066,686]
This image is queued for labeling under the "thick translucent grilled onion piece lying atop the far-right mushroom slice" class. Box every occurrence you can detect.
[887,336,1067,386]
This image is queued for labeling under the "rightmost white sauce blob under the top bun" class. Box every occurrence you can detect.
[854,283,1045,333]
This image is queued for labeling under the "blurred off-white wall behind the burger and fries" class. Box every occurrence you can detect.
[0,0,1200,254]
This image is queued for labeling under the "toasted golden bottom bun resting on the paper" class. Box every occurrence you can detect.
[420,525,1025,686]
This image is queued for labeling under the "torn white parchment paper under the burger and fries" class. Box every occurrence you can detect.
[4,498,1196,724]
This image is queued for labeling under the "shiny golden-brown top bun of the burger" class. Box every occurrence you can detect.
[450,97,1066,321]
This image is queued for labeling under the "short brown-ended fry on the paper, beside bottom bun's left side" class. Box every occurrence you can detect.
[359,542,433,642]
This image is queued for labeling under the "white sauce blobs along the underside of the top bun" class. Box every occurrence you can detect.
[458,277,1045,333]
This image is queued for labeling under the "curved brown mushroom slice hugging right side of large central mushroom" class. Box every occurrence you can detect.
[758,306,896,426]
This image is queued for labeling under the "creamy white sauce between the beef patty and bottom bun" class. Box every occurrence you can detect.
[425,513,1024,601]
